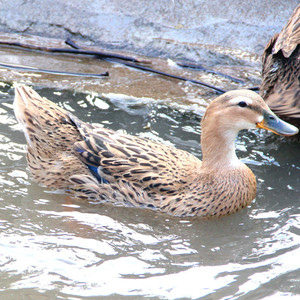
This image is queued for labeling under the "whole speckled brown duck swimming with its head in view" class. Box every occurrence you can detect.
[14,85,298,218]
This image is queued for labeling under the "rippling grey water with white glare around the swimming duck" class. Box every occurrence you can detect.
[0,83,300,299]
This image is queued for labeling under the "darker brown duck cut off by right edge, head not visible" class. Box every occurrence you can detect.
[260,4,300,134]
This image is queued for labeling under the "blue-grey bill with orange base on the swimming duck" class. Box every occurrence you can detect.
[256,110,299,136]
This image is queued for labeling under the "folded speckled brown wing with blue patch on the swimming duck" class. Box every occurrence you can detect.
[69,114,201,194]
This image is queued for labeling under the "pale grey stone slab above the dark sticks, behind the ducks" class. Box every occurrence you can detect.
[0,0,299,57]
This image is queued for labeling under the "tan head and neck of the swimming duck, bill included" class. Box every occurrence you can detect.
[201,90,298,170]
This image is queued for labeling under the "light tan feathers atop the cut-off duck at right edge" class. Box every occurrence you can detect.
[272,5,300,58]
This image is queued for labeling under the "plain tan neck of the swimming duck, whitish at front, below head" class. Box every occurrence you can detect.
[201,124,243,170]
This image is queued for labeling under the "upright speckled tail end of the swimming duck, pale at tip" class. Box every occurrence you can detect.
[14,85,86,188]
